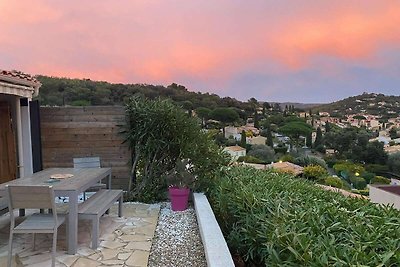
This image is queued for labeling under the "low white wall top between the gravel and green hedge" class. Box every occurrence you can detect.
[193,193,235,267]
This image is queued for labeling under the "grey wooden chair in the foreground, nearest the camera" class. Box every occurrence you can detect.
[6,185,66,267]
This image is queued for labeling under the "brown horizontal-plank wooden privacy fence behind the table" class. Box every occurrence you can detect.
[40,106,130,189]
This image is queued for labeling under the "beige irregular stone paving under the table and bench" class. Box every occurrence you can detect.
[0,203,160,267]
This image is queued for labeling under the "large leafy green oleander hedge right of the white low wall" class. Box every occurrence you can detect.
[210,167,400,266]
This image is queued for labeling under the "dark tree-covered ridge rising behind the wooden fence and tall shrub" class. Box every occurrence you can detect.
[37,76,251,110]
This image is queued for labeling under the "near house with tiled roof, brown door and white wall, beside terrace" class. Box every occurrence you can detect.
[0,70,41,183]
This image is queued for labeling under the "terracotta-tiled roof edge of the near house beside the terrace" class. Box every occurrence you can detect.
[0,70,42,99]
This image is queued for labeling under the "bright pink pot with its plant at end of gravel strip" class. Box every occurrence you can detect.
[166,160,195,211]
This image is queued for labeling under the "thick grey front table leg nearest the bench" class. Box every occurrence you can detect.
[67,192,78,254]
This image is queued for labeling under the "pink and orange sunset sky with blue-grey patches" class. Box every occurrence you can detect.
[0,0,400,103]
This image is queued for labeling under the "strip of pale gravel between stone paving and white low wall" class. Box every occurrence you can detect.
[148,203,207,267]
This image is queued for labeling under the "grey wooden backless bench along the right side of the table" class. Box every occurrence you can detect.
[78,189,123,249]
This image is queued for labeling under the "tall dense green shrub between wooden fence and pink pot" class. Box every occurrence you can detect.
[123,96,228,202]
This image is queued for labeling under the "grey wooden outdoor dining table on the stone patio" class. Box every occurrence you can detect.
[0,168,111,254]
